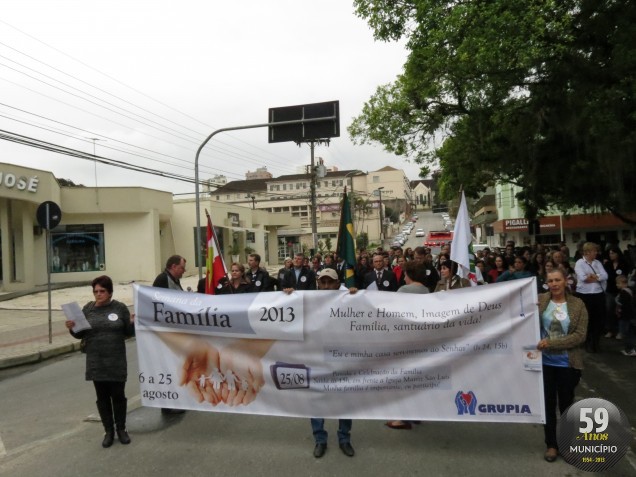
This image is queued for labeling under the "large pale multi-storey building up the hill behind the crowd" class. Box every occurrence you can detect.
[210,167,415,260]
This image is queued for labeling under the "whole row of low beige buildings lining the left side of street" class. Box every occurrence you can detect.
[0,163,293,293]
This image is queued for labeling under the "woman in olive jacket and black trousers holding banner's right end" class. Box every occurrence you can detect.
[537,268,587,462]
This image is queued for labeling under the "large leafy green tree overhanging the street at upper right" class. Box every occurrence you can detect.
[349,0,636,220]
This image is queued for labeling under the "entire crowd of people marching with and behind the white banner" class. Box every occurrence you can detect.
[67,238,636,462]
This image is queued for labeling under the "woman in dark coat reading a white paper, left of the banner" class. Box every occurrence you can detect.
[66,275,135,447]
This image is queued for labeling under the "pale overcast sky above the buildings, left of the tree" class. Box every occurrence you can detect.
[0,0,419,194]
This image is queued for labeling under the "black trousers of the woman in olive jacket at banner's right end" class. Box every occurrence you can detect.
[543,365,581,448]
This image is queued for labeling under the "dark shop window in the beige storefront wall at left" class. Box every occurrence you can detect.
[51,224,106,273]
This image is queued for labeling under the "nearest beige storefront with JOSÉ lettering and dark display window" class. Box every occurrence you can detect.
[0,164,173,292]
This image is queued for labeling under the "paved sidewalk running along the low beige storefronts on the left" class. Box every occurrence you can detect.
[0,275,204,369]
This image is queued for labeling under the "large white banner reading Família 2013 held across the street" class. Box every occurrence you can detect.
[135,279,545,423]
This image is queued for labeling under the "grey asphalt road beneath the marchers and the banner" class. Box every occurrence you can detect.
[0,330,636,477]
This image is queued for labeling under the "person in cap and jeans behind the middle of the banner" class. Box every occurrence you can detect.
[311,268,358,459]
